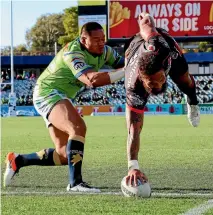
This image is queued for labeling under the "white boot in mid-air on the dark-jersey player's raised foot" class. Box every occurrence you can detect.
[187,103,200,127]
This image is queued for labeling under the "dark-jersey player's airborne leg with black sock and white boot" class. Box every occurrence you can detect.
[171,72,200,127]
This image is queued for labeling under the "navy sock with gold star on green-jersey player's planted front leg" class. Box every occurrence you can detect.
[66,136,84,187]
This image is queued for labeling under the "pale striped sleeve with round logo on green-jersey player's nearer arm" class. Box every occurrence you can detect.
[63,51,93,78]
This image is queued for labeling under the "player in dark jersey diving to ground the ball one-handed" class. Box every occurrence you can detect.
[125,13,200,185]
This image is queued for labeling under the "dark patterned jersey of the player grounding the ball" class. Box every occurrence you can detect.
[124,28,188,113]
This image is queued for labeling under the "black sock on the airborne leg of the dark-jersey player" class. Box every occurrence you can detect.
[178,75,198,105]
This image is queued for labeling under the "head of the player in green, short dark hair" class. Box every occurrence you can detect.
[81,22,105,55]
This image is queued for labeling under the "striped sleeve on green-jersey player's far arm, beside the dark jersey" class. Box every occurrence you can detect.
[104,45,124,69]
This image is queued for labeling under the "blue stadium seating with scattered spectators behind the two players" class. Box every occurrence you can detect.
[1,73,213,105]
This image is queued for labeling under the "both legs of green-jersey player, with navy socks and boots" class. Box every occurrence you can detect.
[4,99,100,192]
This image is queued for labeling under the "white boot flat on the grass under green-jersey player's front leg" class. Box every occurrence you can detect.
[67,182,101,193]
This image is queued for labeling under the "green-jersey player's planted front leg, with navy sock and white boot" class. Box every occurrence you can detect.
[48,99,100,192]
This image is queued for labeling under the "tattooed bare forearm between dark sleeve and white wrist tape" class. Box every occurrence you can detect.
[126,108,144,160]
